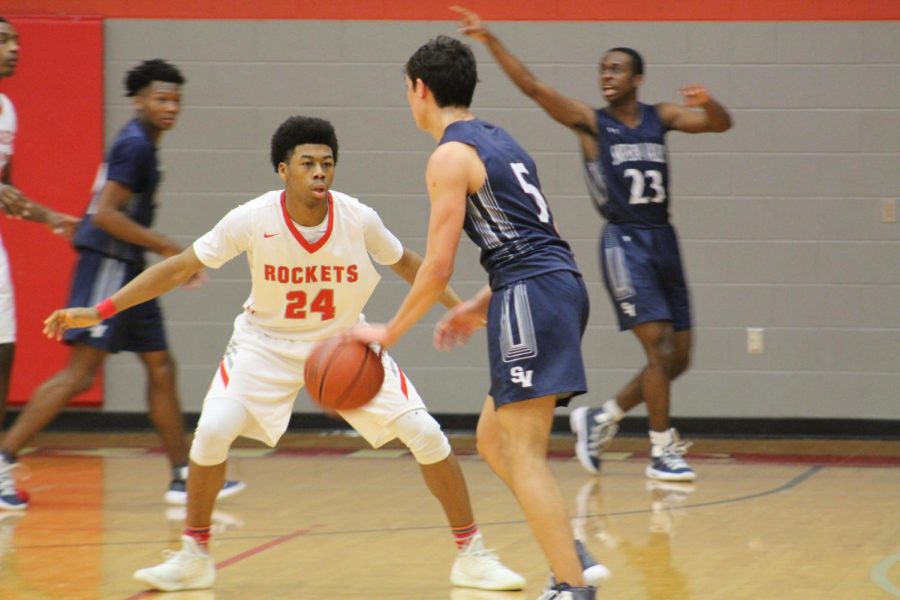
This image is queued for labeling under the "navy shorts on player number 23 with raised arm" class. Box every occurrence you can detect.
[600,223,691,331]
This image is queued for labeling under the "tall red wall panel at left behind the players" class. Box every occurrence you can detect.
[0,13,103,404]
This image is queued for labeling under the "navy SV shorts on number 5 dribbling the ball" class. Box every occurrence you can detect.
[487,271,590,408]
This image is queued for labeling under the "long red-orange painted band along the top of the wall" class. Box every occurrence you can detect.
[0,0,900,21]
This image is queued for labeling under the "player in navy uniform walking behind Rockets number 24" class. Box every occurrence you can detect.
[0,59,244,510]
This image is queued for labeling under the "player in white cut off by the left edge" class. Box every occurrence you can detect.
[0,17,78,509]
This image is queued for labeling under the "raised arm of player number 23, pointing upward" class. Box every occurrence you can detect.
[450,6,597,134]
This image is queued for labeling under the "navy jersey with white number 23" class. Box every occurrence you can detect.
[584,103,669,227]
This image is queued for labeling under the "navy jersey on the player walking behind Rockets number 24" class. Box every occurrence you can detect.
[72,119,161,263]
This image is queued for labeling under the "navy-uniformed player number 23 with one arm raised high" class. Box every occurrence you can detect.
[453,7,731,481]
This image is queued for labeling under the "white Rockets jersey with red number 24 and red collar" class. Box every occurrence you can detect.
[194,190,403,342]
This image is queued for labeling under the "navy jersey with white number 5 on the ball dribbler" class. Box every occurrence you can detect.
[440,119,578,290]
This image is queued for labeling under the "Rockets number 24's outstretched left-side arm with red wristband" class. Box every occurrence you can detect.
[44,246,204,340]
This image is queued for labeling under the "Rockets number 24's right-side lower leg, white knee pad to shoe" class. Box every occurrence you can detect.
[390,409,525,590]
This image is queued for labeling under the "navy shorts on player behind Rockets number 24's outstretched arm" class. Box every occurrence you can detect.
[63,250,168,352]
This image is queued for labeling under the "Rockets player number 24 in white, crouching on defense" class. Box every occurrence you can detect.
[44,117,525,591]
